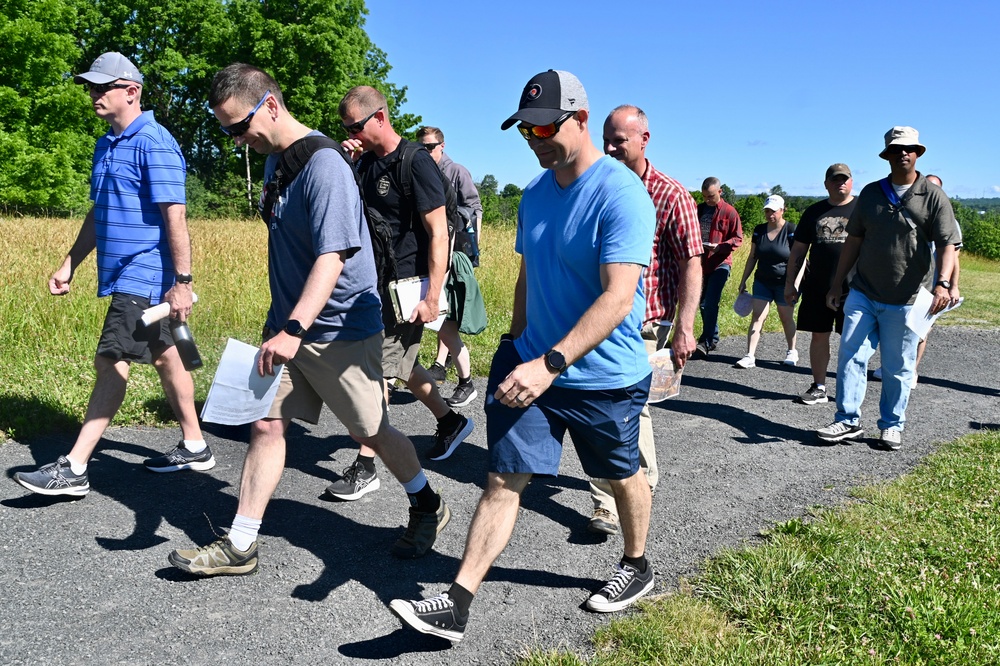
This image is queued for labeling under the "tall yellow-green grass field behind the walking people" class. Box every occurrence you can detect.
[0,217,1000,441]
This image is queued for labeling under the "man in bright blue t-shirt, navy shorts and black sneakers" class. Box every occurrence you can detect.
[390,70,656,642]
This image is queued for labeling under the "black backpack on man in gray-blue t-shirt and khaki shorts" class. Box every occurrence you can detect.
[261,134,396,294]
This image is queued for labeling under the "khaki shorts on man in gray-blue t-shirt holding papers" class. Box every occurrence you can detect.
[267,333,389,437]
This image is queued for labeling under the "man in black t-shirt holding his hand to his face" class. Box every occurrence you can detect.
[328,86,474,500]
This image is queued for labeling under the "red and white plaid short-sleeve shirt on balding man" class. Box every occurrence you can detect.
[642,160,704,323]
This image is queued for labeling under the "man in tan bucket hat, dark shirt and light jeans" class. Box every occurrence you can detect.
[816,127,962,451]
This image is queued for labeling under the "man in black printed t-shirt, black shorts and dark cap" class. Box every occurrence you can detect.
[785,163,855,405]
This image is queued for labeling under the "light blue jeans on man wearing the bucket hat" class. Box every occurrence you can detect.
[835,289,920,430]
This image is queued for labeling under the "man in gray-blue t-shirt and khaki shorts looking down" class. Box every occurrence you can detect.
[168,63,451,576]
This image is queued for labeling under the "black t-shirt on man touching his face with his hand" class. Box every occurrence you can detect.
[358,139,445,278]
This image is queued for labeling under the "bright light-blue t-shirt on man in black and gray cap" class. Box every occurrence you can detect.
[514,156,656,390]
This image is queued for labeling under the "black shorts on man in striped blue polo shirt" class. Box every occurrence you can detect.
[97,294,174,364]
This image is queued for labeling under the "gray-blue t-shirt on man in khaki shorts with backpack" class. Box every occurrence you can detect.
[264,132,383,342]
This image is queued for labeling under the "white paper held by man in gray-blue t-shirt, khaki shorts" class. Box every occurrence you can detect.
[201,338,285,425]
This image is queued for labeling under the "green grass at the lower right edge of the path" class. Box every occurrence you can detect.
[517,432,1000,666]
